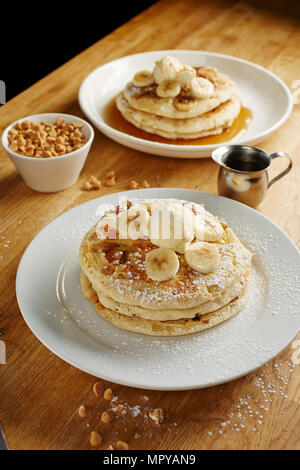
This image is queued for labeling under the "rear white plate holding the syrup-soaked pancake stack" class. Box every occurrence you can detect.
[79,50,293,158]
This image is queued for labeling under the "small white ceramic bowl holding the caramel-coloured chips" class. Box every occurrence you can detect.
[2,113,94,193]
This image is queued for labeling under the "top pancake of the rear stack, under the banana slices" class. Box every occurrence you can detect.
[123,66,237,119]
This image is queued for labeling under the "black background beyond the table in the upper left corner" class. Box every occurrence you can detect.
[0,0,156,101]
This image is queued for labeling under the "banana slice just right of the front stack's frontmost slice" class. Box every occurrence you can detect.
[184,241,219,274]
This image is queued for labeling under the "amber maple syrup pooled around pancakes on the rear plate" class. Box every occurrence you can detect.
[104,98,252,145]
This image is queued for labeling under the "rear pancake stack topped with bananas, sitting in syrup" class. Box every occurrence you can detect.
[116,56,241,140]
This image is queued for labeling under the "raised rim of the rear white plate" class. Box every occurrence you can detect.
[78,49,293,158]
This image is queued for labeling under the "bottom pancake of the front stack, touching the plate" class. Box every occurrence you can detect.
[81,272,248,336]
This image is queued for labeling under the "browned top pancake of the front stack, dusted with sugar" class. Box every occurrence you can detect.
[79,201,251,310]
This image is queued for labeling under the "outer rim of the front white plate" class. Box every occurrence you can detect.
[16,188,300,391]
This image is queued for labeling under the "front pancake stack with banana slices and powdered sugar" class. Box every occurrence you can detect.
[79,200,251,336]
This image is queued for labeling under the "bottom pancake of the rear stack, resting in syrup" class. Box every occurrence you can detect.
[116,94,241,139]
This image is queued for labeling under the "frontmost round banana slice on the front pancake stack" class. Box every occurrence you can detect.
[145,248,179,281]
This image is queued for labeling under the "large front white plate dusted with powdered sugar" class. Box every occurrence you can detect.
[16,188,300,390]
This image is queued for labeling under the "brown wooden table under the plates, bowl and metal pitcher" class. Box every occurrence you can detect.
[0,0,300,449]
